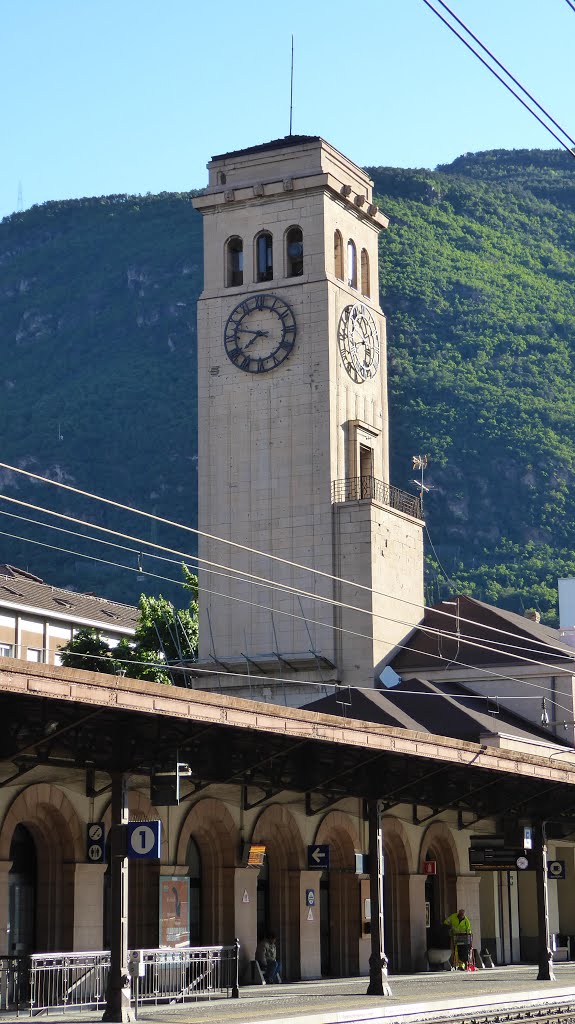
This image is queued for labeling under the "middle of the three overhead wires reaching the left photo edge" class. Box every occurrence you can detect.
[0,485,571,675]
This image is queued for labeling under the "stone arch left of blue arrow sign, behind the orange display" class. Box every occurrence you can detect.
[252,804,306,981]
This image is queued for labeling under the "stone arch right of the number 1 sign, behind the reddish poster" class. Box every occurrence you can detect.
[176,797,239,945]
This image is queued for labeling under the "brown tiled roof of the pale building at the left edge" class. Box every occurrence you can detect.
[0,564,138,631]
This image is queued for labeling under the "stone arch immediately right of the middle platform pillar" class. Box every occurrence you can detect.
[382,816,413,974]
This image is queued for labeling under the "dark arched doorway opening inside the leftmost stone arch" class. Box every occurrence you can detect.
[8,824,38,956]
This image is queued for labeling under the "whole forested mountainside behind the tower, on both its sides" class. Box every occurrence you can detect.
[0,151,575,621]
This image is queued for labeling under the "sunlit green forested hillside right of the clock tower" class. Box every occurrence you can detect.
[370,151,575,621]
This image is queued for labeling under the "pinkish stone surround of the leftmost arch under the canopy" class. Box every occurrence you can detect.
[0,782,85,952]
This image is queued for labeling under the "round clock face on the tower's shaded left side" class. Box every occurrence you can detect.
[224,295,296,374]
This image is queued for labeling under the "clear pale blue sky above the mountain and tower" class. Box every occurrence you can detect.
[0,0,575,217]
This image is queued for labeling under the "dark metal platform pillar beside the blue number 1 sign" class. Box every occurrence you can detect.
[102,771,134,1024]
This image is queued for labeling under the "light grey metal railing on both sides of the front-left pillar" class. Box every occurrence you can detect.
[29,942,239,1016]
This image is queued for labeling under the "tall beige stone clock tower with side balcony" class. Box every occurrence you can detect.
[193,136,423,705]
